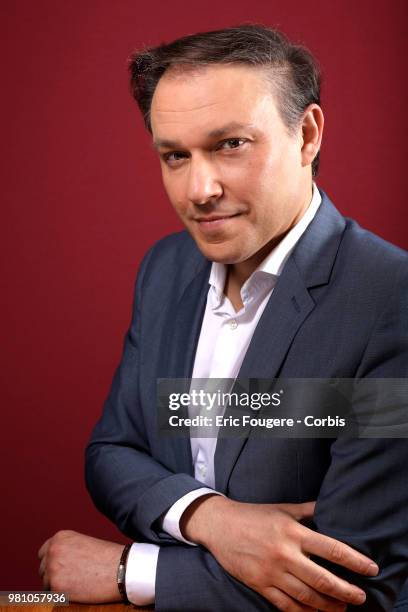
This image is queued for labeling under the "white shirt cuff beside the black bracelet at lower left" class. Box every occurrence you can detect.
[125,543,160,606]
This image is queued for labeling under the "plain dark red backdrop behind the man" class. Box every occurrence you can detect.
[0,0,408,589]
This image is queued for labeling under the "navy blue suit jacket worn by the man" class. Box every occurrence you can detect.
[86,194,408,612]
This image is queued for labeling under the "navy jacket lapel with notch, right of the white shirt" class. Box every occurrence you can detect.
[215,193,345,493]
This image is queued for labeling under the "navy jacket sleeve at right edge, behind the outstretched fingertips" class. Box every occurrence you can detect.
[314,272,408,612]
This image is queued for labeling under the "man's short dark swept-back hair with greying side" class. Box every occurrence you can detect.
[129,24,320,176]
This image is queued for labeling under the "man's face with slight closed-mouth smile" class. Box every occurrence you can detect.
[151,64,311,265]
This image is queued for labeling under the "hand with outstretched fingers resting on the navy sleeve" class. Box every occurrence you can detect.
[181,495,378,612]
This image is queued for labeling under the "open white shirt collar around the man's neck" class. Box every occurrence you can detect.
[208,183,322,308]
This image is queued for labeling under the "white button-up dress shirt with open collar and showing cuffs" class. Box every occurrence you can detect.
[126,183,321,606]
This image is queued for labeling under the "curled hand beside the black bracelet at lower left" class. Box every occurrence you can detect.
[38,531,123,603]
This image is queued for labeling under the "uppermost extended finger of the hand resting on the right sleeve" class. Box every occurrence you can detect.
[301,527,379,576]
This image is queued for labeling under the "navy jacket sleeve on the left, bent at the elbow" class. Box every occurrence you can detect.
[85,245,202,544]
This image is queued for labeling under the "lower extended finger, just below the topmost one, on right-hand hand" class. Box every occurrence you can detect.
[290,557,366,606]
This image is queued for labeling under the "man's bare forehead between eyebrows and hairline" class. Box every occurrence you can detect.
[151,64,277,139]
